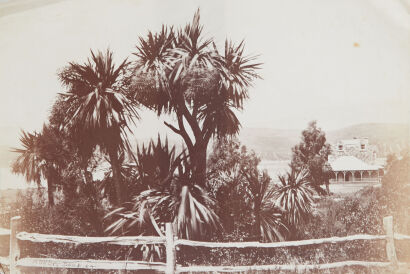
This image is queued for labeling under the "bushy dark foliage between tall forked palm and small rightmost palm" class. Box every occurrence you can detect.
[208,139,288,241]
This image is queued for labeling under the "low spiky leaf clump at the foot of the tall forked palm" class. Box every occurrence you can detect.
[107,138,219,239]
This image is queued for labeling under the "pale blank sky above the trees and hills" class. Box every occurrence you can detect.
[0,0,410,145]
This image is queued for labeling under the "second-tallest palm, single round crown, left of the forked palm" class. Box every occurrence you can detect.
[59,50,138,204]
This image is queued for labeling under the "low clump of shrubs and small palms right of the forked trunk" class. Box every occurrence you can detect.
[208,140,314,242]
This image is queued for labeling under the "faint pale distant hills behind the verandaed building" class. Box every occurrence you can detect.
[239,123,410,160]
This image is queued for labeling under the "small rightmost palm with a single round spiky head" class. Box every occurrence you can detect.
[273,168,314,237]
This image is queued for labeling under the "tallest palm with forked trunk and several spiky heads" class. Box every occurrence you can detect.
[131,10,259,187]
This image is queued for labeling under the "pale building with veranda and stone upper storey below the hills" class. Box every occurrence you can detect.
[328,138,384,183]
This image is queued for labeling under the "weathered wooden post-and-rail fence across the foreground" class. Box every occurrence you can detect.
[0,216,410,274]
